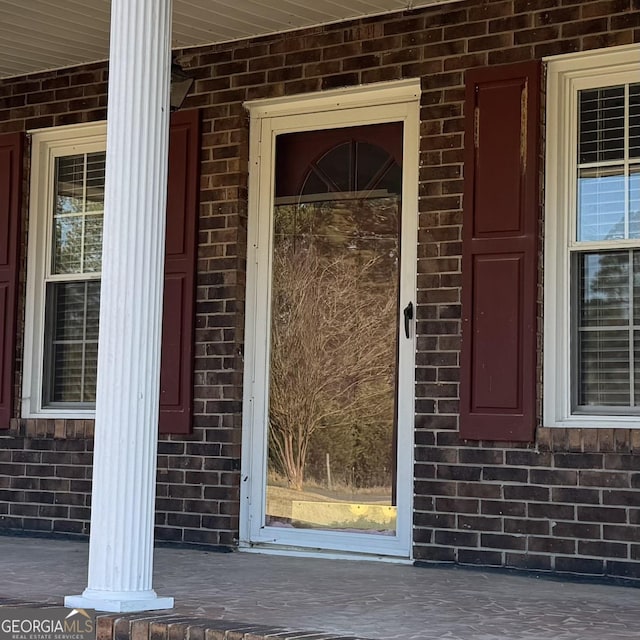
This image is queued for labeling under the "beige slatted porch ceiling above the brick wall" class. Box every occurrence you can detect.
[0,0,458,78]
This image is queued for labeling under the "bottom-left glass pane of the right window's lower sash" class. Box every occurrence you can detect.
[578,330,630,407]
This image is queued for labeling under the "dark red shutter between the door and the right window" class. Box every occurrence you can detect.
[460,62,540,441]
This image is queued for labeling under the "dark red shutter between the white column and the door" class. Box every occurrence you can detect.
[160,111,200,433]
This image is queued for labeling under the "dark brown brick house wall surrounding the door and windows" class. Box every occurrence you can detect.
[0,0,640,577]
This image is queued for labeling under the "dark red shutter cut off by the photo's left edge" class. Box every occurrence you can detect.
[0,133,23,429]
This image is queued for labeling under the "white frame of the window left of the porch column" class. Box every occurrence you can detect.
[22,122,107,418]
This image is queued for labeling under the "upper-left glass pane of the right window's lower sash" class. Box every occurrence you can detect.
[579,251,629,327]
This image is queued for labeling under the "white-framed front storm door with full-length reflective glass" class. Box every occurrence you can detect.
[241,81,419,557]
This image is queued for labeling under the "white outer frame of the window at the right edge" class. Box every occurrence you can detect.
[543,45,640,428]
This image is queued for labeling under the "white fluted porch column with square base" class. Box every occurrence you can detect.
[65,0,173,612]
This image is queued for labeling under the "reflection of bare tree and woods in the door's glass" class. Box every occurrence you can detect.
[269,201,397,489]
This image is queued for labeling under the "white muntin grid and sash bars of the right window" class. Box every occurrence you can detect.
[568,82,640,416]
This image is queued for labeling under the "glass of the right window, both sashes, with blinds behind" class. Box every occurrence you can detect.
[570,80,640,415]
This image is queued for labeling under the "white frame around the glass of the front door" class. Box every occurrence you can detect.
[239,79,421,559]
